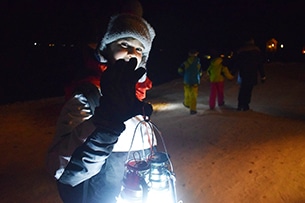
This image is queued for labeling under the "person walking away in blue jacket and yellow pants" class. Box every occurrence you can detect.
[178,49,202,114]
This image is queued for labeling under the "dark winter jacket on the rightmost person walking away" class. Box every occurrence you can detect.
[234,43,265,85]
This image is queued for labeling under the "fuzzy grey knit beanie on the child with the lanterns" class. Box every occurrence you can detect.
[99,13,155,67]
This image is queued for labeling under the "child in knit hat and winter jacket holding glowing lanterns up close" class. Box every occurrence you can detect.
[47,0,156,203]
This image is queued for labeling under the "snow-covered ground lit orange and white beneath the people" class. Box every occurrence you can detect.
[0,63,305,203]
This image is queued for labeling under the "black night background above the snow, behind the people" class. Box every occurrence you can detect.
[0,0,305,103]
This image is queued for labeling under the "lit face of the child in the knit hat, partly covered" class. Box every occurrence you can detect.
[109,38,144,68]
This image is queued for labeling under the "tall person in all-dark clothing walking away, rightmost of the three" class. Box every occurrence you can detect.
[234,38,266,111]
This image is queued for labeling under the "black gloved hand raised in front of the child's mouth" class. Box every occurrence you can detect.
[93,58,153,133]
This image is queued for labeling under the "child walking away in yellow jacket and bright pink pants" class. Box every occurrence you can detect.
[207,51,234,109]
